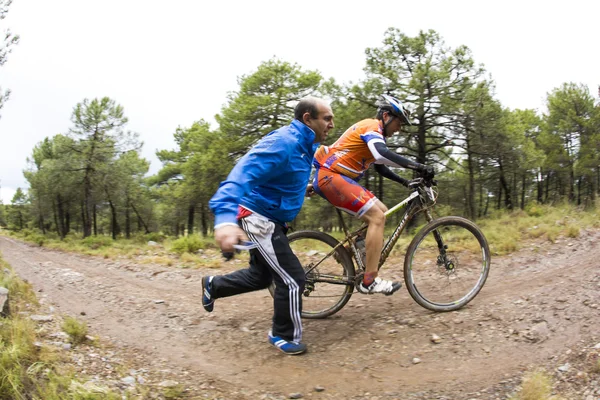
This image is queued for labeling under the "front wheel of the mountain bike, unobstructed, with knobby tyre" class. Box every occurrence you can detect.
[404,217,490,311]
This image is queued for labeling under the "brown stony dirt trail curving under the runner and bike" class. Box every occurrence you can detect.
[0,231,600,400]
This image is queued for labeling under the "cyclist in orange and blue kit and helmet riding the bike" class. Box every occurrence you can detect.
[309,94,434,295]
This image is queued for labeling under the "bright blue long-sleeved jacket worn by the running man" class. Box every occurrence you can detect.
[208,119,318,226]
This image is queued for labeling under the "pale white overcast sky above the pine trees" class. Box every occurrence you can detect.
[0,0,600,204]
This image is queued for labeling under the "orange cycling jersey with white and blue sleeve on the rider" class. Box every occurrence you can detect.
[314,119,385,180]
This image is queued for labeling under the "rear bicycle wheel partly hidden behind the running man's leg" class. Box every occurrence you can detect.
[269,231,354,319]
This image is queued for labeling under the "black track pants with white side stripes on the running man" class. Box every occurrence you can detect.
[212,214,305,342]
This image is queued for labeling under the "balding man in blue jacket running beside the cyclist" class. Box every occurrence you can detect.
[202,97,334,354]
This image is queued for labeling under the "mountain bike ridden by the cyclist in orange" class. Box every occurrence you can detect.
[269,178,491,319]
